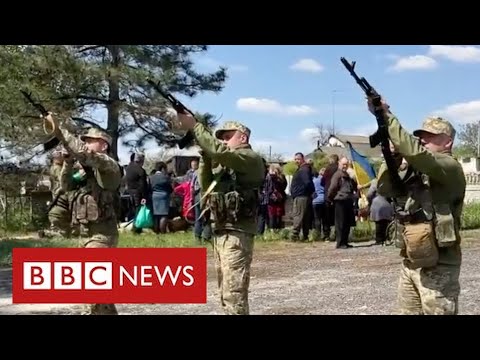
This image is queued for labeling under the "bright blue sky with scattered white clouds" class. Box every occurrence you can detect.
[120,45,480,162]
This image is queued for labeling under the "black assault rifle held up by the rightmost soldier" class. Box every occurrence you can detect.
[340,57,404,197]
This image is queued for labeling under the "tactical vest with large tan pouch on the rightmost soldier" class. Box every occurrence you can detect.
[396,173,457,268]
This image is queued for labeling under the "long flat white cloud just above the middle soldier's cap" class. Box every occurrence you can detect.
[237,97,316,116]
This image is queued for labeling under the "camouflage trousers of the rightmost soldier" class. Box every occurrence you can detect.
[398,264,460,315]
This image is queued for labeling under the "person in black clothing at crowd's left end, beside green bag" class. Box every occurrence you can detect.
[125,154,148,233]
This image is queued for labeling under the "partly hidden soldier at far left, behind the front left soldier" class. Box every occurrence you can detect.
[43,147,71,237]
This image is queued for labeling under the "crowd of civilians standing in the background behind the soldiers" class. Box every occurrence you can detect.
[123,153,393,249]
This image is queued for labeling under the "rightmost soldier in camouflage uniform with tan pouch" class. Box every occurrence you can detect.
[369,98,466,315]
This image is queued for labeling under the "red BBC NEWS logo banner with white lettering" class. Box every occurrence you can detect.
[12,248,207,304]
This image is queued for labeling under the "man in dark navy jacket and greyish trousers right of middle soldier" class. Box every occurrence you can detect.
[290,153,315,241]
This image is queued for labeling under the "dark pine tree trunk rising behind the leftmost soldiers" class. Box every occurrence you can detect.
[107,45,121,161]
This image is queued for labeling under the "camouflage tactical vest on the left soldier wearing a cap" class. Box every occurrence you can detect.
[71,166,116,225]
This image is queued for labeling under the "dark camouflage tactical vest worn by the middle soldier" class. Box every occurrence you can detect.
[207,168,259,228]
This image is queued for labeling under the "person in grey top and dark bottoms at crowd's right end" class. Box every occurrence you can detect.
[367,180,394,245]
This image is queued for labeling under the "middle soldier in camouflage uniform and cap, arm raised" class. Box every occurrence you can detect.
[172,114,265,315]
